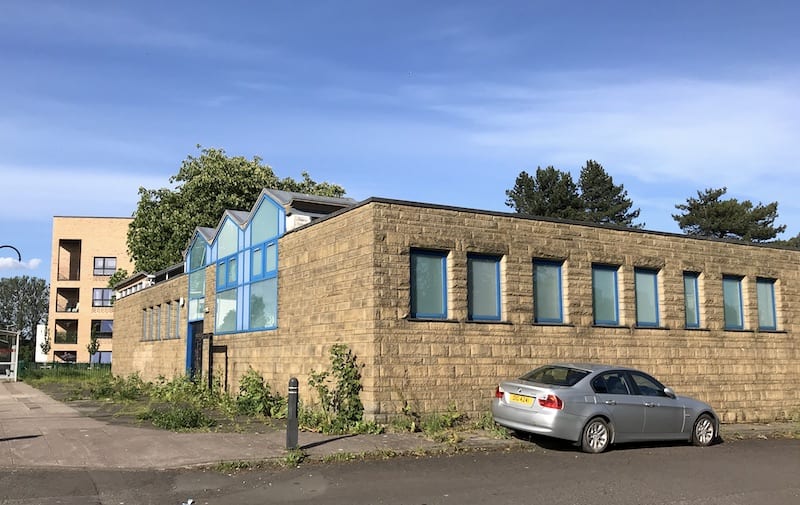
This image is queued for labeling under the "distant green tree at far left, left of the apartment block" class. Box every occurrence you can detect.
[0,276,50,358]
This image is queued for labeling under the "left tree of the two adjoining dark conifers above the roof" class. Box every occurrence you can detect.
[506,166,583,219]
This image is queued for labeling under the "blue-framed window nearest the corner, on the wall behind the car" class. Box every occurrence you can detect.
[411,250,447,319]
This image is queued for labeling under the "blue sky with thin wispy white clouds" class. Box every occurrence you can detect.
[0,0,800,278]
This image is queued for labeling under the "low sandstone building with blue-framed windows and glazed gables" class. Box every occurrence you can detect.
[113,190,800,422]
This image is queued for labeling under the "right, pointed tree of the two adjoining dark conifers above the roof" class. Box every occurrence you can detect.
[578,160,644,228]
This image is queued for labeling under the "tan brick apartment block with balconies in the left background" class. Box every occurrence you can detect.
[47,216,134,363]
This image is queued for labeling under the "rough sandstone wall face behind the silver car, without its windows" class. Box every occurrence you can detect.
[370,201,800,422]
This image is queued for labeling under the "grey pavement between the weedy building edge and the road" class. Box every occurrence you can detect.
[0,381,798,470]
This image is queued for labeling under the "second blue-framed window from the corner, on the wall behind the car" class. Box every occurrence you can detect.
[467,255,500,321]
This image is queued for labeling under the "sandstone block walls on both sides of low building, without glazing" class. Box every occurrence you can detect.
[114,199,800,422]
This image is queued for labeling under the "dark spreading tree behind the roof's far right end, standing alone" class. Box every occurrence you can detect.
[672,187,786,242]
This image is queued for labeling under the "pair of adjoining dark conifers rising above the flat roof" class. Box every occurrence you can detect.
[506,160,642,228]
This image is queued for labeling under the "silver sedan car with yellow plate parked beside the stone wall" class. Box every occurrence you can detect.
[492,364,719,453]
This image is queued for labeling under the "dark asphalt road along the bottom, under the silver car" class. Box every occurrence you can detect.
[0,440,800,505]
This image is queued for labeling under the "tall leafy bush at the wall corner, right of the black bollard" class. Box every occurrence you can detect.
[298,344,364,433]
